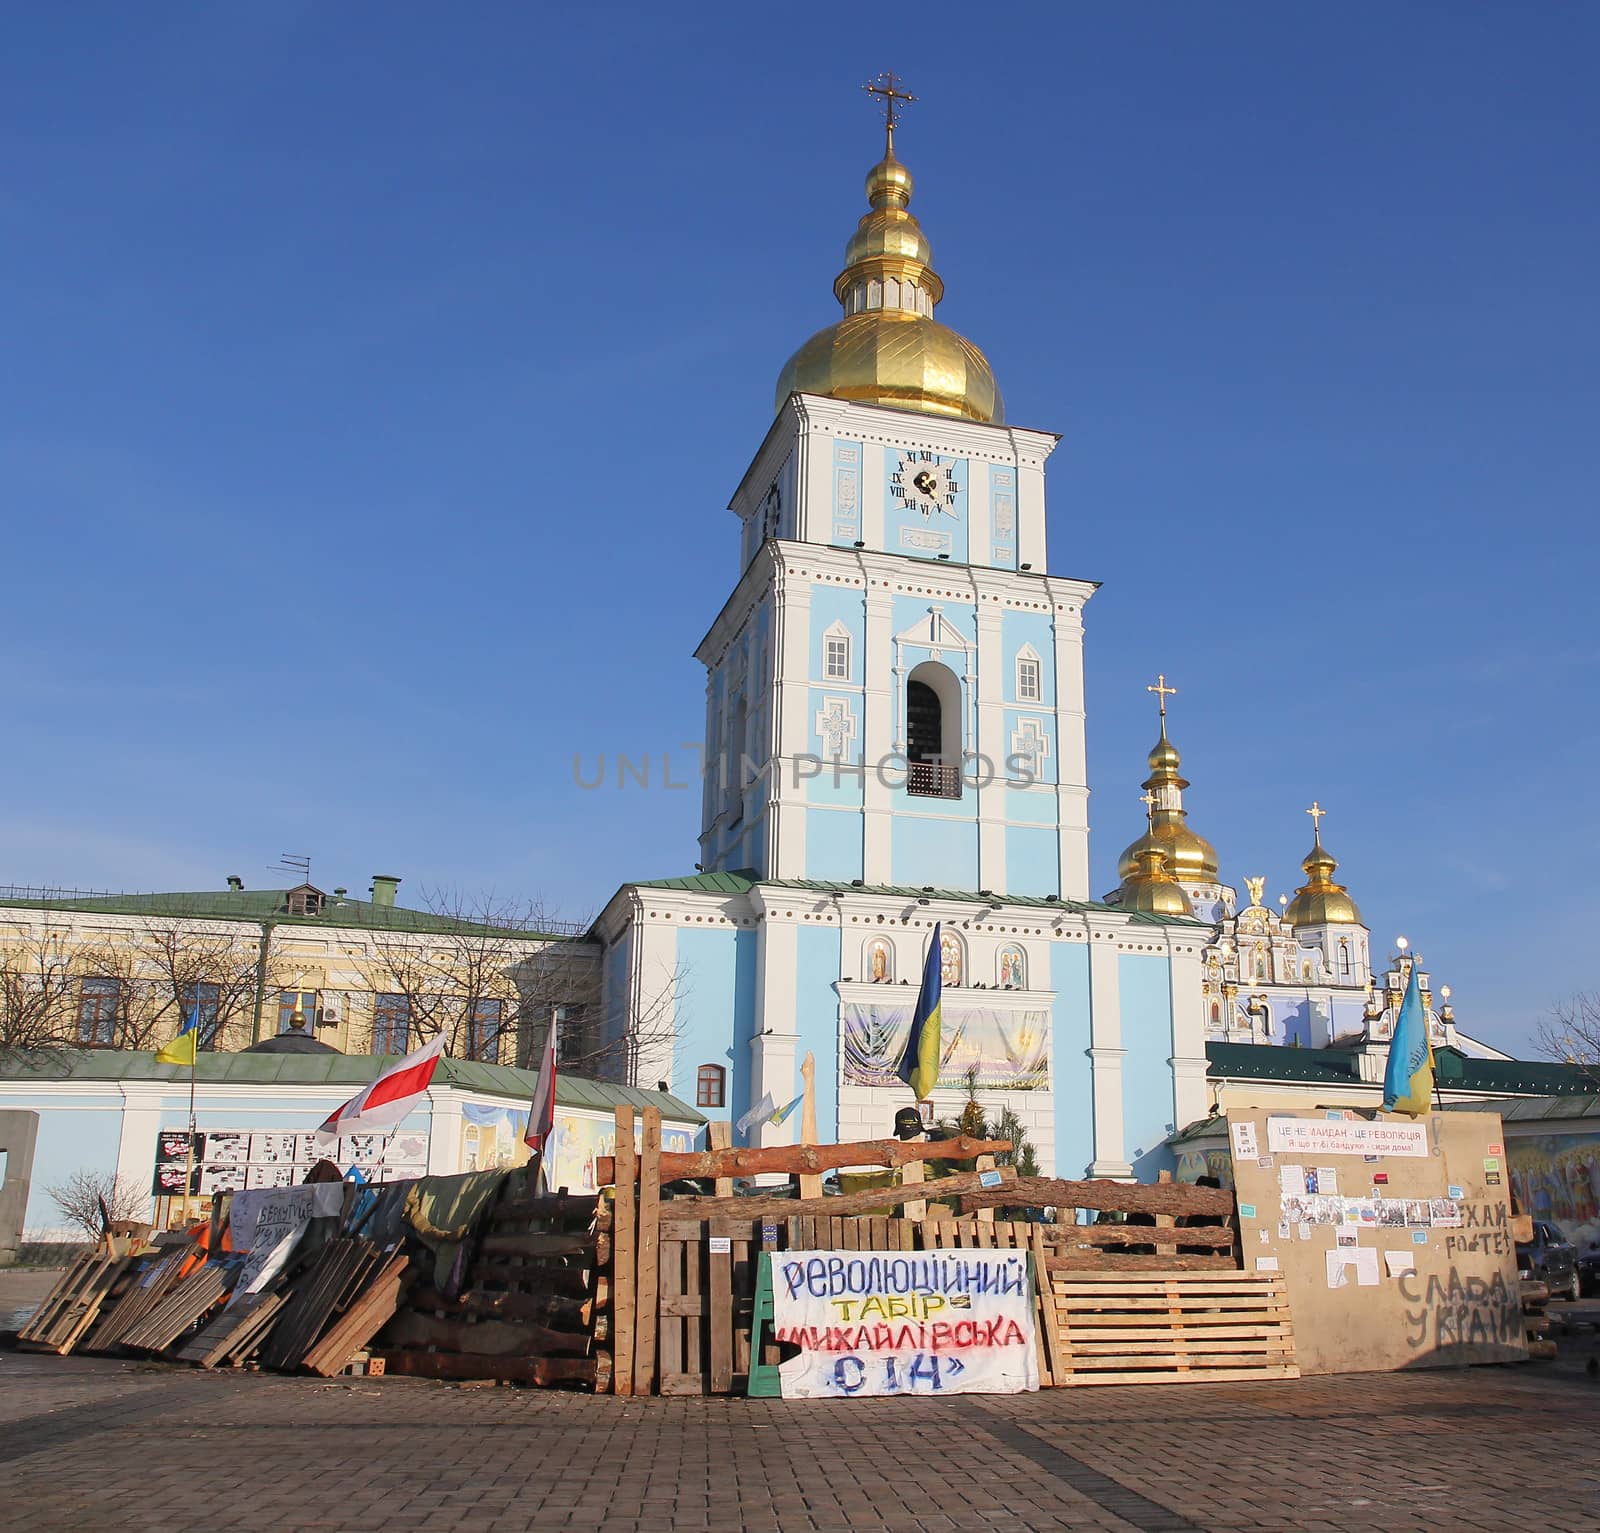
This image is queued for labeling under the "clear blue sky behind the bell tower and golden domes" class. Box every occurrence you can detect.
[0,0,1600,1047]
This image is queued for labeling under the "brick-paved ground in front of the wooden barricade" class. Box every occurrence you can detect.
[0,1352,1600,1533]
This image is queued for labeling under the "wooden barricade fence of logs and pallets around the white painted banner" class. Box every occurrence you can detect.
[608,1107,1254,1395]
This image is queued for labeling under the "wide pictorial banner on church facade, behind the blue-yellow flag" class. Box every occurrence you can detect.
[843,1011,1050,1091]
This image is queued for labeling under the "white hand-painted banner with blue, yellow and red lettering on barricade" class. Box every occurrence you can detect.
[771,1250,1038,1400]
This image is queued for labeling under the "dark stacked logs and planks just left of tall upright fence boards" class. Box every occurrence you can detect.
[374,1171,611,1387]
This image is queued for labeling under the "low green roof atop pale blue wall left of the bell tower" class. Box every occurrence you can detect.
[0,1048,706,1123]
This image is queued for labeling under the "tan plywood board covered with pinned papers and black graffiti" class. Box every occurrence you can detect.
[1227,1107,1528,1373]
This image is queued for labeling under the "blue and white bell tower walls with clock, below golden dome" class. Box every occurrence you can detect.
[595,394,1211,1176]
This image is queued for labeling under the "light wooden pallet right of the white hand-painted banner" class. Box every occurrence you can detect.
[1050,1259,1299,1384]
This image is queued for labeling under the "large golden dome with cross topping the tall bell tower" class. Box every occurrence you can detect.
[773,74,1005,426]
